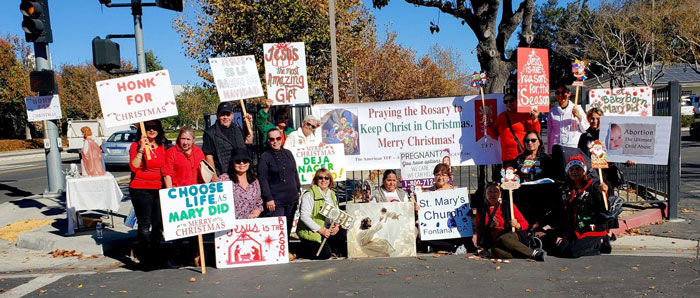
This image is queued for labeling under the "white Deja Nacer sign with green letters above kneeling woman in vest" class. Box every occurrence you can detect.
[291,144,347,184]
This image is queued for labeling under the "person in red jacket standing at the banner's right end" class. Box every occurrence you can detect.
[486,94,540,162]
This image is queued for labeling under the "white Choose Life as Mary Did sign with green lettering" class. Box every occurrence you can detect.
[159,181,236,241]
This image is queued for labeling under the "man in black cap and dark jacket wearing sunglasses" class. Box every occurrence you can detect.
[202,102,253,182]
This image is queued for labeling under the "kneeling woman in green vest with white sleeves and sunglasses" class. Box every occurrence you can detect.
[297,168,347,260]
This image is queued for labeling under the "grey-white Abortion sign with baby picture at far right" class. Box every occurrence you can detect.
[599,116,672,165]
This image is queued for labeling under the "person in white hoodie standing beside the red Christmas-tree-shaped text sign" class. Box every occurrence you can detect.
[547,85,590,154]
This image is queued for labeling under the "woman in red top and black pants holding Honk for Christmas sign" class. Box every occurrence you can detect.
[129,120,166,265]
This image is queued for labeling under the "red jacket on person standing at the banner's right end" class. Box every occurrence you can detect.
[487,112,540,161]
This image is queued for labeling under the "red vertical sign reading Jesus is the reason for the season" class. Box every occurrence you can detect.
[517,48,549,113]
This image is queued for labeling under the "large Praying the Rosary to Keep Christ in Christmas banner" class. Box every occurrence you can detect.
[312,94,504,171]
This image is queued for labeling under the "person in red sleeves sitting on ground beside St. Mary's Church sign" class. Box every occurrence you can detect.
[476,183,546,262]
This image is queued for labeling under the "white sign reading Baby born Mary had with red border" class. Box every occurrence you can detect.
[588,87,654,116]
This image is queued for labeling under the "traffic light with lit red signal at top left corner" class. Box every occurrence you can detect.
[19,0,53,43]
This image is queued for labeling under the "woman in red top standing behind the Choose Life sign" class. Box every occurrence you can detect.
[162,126,204,188]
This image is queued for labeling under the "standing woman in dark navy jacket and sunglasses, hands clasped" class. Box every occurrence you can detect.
[258,128,301,235]
